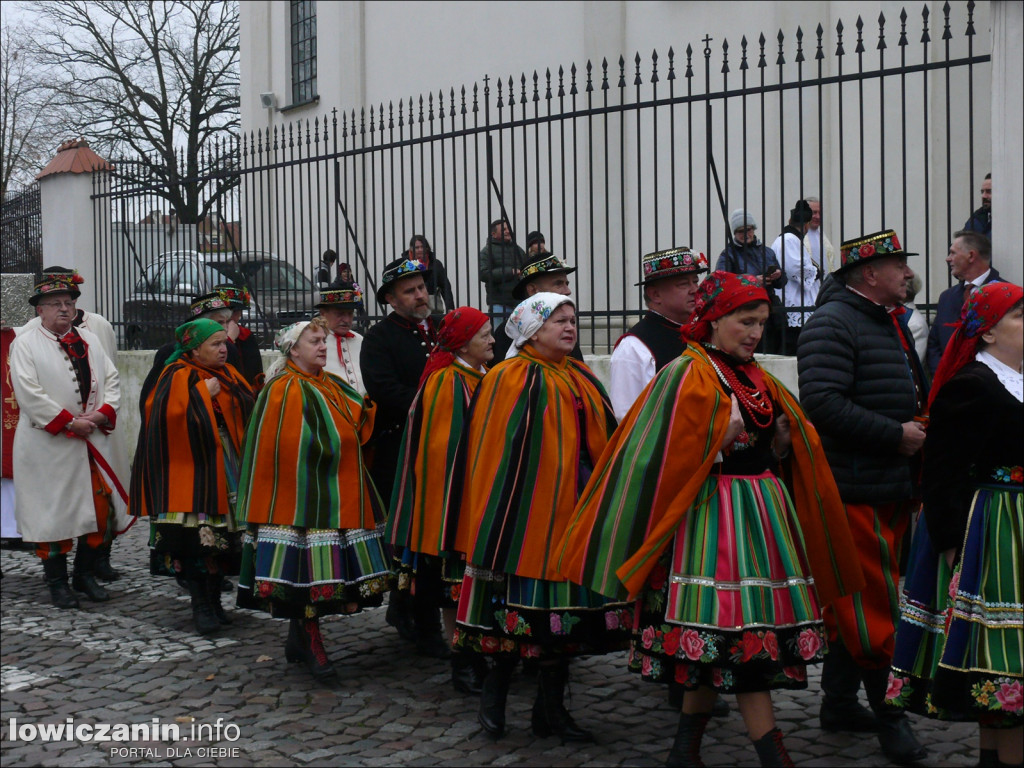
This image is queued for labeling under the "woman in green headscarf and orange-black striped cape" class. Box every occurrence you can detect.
[130,318,254,635]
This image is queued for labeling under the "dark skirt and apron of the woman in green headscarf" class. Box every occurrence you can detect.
[150,428,242,577]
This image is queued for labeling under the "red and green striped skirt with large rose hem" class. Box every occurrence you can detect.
[630,472,826,693]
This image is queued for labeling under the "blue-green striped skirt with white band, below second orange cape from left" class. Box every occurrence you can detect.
[239,523,394,618]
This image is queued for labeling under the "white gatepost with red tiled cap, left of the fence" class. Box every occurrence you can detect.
[36,139,112,310]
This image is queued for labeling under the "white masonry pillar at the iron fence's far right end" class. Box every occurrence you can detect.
[991,0,1024,285]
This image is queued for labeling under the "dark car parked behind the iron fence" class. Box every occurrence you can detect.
[124,251,316,349]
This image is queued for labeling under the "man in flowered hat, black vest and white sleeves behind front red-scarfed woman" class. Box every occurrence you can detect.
[609,246,708,421]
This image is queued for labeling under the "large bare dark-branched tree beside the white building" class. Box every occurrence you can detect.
[31,0,239,223]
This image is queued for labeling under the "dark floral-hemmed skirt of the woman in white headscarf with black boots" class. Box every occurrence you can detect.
[453,565,633,658]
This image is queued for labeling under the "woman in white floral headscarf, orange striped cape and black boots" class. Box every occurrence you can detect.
[445,293,630,741]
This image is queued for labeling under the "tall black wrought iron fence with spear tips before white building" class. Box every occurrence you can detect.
[94,2,991,351]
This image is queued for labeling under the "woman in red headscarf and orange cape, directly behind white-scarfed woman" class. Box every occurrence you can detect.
[387,306,495,693]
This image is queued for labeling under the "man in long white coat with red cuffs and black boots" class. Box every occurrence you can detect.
[10,273,129,608]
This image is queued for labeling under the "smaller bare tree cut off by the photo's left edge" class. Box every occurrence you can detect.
[0,23,57,200]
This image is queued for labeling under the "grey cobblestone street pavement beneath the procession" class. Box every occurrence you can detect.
[0,524,977,768]
